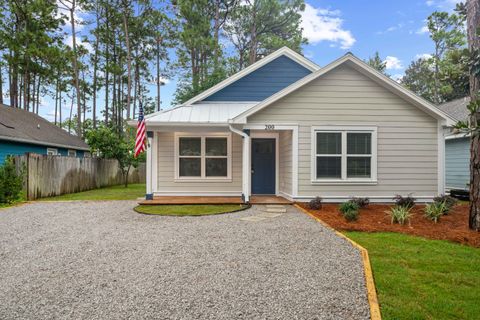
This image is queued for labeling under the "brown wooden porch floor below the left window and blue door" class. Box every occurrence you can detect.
[138,196,292,205]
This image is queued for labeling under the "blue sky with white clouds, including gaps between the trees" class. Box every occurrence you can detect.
[32,0,459,120]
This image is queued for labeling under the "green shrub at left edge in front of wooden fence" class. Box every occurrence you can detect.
[0,158,23,203]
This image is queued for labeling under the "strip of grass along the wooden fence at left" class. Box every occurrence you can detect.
[38,183,145,201]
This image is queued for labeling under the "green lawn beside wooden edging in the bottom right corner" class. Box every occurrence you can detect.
[345,232,480,319]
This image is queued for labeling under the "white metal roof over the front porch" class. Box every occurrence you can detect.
[147,101,258,125]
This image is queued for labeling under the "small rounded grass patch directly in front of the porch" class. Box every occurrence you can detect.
[135,204,247,216]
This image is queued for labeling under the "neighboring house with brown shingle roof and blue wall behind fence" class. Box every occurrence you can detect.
[0,104,90,165]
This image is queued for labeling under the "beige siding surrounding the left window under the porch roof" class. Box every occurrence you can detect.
[156,132,242,195]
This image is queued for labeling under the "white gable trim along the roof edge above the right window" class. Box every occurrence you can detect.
[231,53,457,126]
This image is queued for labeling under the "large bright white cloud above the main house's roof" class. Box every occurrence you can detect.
[300,3,356,49]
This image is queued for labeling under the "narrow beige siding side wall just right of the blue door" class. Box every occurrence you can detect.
[278,130,292,195]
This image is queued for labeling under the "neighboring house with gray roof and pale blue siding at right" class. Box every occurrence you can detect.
[438,97,470,190]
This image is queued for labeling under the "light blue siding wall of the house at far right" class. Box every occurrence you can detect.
[445,138,470,189]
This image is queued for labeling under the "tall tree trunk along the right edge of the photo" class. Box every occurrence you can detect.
[466,0,480,231]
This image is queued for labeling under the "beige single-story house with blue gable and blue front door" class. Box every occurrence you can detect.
[142,48,455,202]
